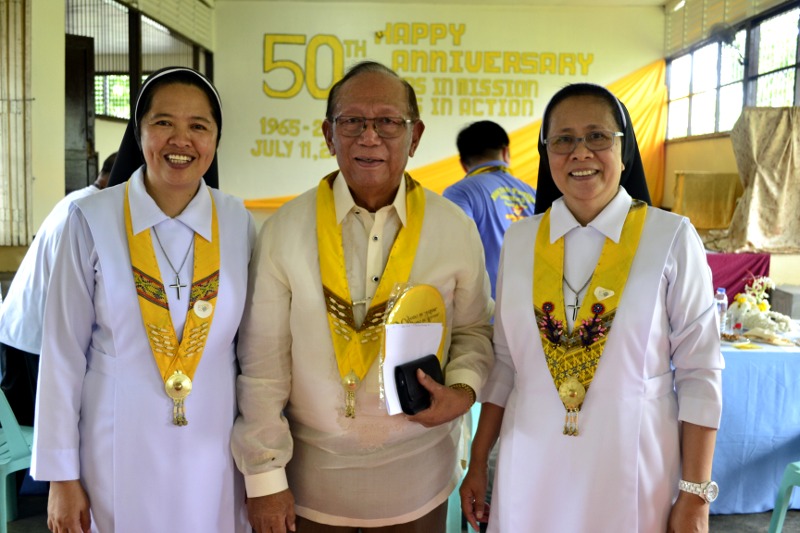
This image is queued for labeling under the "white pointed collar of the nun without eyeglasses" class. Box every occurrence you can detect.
[128,165,211,241]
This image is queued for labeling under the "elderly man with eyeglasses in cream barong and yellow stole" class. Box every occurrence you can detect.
[233,62,493,533]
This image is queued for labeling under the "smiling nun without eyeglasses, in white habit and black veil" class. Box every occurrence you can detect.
[31,67,255,533]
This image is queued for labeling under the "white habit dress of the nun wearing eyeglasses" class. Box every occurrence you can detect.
[483,189,724,533]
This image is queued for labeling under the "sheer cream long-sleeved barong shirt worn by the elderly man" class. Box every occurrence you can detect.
[233,175,493,527]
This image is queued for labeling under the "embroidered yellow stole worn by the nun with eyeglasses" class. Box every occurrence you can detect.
[533,200,647,436]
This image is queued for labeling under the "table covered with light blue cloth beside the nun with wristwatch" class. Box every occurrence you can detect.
[711,344,800,514]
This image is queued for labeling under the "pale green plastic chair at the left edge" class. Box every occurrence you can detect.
[0,386,33,533]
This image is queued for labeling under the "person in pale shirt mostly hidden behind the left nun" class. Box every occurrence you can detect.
[0,152,117,426]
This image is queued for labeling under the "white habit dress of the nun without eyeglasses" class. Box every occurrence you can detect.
[31,167,255,533]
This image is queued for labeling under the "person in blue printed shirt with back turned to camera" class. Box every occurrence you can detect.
[443,120,536,298]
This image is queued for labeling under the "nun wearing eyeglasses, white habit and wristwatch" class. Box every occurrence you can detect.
[461,84,724,533]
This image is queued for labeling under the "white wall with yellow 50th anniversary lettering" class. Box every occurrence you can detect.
[214,0,664,198]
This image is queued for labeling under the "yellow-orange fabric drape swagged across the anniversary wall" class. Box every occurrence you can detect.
[245,59,667,209]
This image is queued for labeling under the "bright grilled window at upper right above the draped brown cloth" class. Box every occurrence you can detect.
[667,3,800,139]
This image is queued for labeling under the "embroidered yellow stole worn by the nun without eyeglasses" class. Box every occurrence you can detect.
[124,184,220,426]
